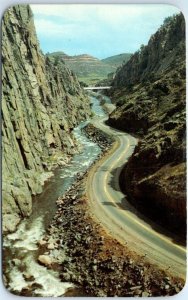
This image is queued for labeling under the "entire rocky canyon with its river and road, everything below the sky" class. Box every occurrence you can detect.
[2,5,186,297]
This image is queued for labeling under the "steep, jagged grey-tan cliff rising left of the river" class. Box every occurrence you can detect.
[2,5,90,232]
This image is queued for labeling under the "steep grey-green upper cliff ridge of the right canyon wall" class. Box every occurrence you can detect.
[113,15,185,88]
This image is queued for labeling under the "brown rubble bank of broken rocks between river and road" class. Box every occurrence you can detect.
[38,125,184,296]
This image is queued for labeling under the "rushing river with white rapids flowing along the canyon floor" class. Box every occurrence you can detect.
[3,96,109,297]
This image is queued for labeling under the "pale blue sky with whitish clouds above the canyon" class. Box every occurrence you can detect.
[30,4,179,59]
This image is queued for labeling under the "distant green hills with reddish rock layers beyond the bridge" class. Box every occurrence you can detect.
[47,52,116,84]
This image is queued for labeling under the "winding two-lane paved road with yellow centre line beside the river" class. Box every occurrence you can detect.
[87,118,186,278]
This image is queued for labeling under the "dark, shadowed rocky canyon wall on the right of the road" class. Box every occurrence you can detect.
[109,14,186,234]
